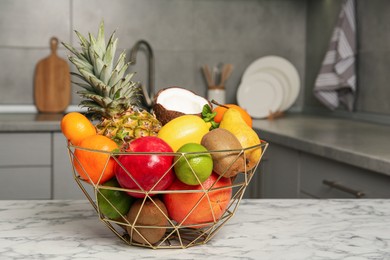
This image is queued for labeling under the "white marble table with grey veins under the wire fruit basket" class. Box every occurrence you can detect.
[0,199,390,260]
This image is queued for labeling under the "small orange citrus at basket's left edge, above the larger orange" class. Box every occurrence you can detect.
[61,112,96,145]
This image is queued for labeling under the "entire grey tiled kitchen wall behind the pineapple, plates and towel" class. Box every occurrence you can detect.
[0,0,390,122]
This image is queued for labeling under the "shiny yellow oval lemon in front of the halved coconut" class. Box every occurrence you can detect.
[157,115,211,152]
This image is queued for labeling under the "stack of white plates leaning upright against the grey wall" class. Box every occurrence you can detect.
[237,56,300,118]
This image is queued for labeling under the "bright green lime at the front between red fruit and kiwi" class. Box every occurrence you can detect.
[174,143,213,185]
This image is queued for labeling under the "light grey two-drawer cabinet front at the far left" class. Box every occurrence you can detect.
[0,133,52,199]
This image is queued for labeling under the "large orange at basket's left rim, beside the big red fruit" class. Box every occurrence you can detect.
[73,135,118,184]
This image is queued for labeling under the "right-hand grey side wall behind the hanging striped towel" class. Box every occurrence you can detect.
[304,0,390,123]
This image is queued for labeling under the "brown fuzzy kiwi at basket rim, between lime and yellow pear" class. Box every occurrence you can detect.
[201,128,245,178]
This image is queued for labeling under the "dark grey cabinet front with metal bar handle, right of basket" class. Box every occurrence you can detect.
[260,142,390,198]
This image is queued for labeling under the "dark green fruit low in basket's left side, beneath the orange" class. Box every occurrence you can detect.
[97,178,134,219]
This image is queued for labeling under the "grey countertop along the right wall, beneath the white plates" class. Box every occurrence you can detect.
[253,114,390,176]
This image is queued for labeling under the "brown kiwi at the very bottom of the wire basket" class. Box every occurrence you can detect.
[127,198,168,244]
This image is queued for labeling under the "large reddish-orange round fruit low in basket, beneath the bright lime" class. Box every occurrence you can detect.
[163,173,232,228]
